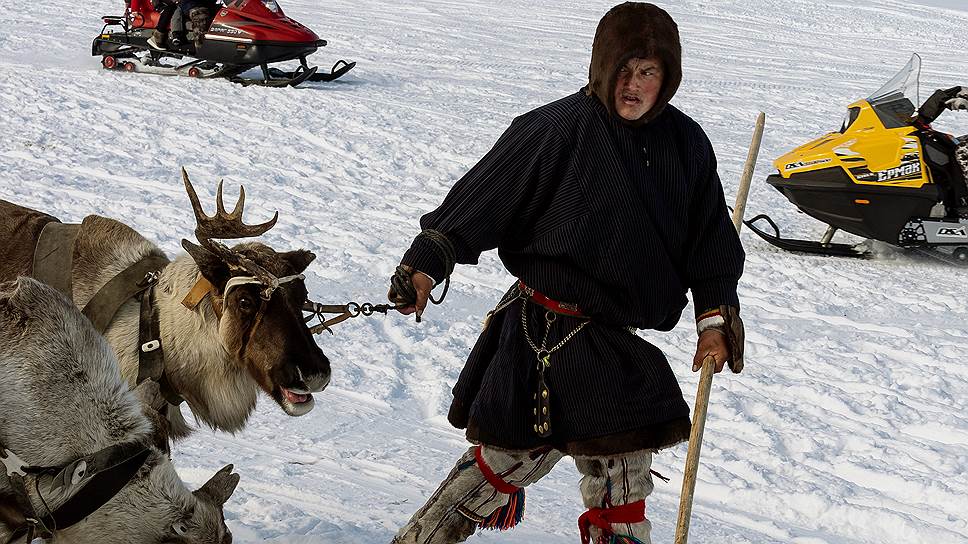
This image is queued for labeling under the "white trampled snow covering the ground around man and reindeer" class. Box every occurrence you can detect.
[0,0,968,544]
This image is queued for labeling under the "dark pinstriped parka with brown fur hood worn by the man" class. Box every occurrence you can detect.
[402,6,744,456]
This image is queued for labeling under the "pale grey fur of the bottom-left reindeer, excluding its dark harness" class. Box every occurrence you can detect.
[0,278,237,544]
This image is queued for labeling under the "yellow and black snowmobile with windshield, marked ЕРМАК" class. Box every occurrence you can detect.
[746,55,968,262]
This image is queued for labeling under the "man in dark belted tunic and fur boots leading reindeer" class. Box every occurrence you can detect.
[390,2,744,544]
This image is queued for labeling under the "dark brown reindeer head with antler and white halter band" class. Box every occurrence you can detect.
[182,169,330,416]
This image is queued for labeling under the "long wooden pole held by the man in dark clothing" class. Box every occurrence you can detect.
[675,112,766,544]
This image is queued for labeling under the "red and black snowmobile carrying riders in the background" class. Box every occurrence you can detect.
[91,0,356,87]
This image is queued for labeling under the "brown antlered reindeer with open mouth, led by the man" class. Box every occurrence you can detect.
[0,169,330,440]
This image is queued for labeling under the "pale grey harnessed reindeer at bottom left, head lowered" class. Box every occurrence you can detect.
[0,278,239,544]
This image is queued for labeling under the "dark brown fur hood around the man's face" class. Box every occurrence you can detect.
[586,2,682,126]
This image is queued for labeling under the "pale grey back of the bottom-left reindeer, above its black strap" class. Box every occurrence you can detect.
[0,278,151,466]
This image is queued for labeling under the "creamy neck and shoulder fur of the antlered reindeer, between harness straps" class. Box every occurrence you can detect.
[67,216,259,438]
